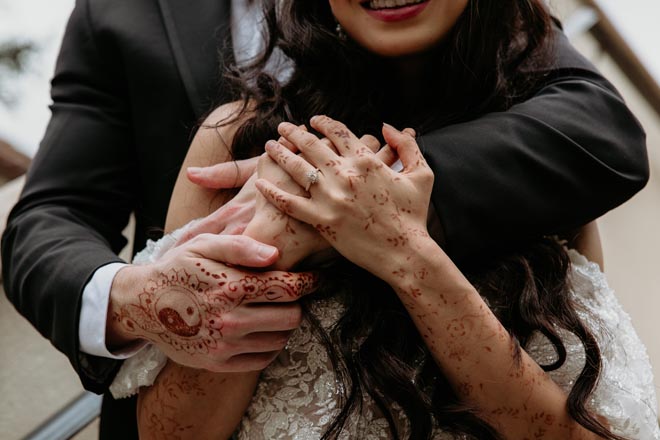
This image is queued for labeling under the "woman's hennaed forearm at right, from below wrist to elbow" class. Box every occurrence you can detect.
[386,239,596,439]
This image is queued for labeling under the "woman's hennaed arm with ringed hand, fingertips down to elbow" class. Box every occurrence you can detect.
[257,117,597,439]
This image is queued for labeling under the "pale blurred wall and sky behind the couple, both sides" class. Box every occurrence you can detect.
[0,0,660,440]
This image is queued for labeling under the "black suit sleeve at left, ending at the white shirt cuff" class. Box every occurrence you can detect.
[2,1,136,392]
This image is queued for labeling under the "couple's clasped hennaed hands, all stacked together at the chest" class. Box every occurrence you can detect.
[109,117,433,372]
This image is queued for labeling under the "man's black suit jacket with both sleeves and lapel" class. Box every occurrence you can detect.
[2,0,648,438]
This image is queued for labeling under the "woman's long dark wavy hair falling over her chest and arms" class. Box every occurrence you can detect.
[215,0,620,440]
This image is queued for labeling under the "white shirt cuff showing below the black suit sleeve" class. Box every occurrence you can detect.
[78,263,147,359]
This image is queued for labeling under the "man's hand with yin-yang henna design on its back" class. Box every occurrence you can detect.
[107,234,316,372]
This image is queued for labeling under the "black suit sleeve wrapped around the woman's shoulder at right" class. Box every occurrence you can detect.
[419,30,649,262]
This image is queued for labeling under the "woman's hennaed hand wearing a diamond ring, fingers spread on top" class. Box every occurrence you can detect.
[256,116,433,279]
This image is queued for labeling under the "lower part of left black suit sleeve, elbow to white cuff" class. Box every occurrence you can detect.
[2,205,128,393]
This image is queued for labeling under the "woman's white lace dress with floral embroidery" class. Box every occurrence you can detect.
[111,229,660,440]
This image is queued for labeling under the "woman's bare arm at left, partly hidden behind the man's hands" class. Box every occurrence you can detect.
[138,104,327,439]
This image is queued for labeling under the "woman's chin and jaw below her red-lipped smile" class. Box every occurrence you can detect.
[330,0,467,57]
